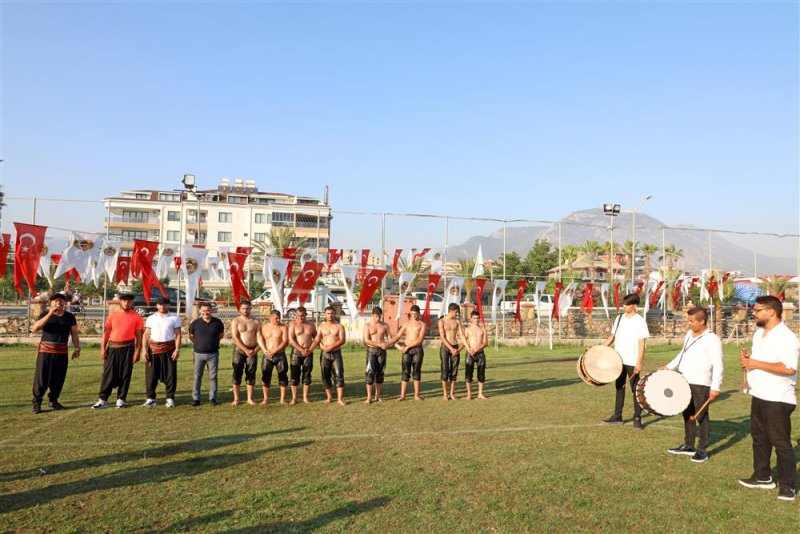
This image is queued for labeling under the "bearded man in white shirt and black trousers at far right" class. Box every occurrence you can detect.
[739,295,800,501]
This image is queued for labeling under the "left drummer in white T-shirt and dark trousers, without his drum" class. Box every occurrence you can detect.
[603,293,650,430]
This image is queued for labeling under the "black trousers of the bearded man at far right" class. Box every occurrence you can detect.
[750,397,797,488]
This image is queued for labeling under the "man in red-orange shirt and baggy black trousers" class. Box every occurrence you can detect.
[92,293,144,410]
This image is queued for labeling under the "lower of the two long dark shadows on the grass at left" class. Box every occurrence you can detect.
[0,441,313,513]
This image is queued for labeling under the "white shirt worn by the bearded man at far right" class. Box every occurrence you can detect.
[747,321,800,405]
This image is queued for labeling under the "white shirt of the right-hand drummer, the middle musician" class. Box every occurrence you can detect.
[667,328,723,391]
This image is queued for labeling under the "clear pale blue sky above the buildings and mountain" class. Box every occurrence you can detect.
[0,0,800,255]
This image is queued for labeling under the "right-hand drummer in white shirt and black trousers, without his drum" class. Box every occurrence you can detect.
[661,308,723,463]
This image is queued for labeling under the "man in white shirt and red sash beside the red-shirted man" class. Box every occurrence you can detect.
[142,297,181,408]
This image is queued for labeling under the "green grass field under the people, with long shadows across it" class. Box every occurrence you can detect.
[0,346,800,532]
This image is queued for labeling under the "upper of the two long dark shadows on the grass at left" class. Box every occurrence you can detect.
[0,427,306,482]
